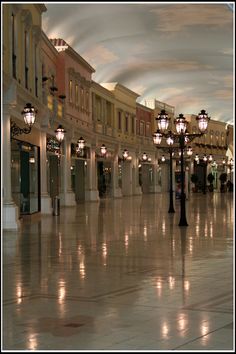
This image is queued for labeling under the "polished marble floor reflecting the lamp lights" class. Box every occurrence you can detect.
[2,193,235,351]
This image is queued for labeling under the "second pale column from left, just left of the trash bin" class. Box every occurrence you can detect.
[40,131,52,214]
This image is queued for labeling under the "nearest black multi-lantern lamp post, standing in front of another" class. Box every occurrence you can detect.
[155,109,210,226]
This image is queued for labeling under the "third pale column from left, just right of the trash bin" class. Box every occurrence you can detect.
[60,136,76,206]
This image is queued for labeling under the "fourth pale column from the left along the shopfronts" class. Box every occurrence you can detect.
[85,146,99,201]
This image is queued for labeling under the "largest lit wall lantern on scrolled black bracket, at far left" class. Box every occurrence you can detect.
[11,103,37,138]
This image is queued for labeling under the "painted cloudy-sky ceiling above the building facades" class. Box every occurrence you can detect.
[43,2,235,124]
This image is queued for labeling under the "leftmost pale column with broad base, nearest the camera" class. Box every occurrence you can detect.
[2,106,20,230]
